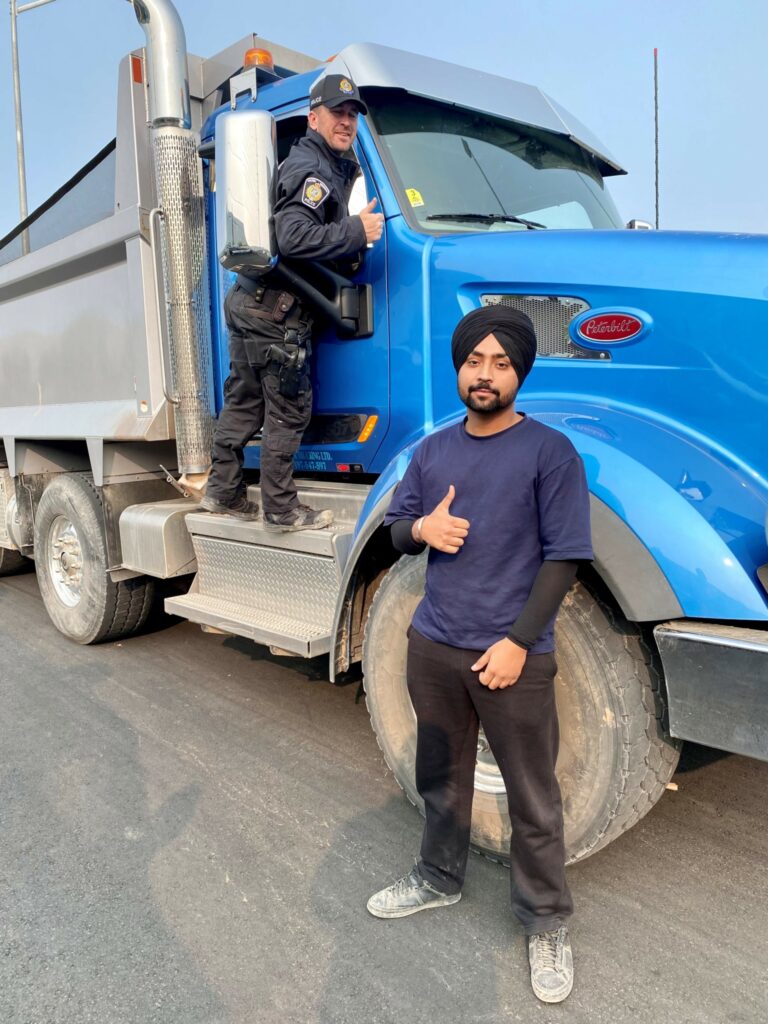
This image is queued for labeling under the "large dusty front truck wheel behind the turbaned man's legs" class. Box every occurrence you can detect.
[362,558,680,863]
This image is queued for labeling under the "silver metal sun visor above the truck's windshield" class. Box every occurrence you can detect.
[328,43,627,177]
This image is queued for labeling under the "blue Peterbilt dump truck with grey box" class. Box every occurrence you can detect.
[0,0,768,860]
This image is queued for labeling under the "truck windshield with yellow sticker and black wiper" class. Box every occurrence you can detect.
[366,89,623,233]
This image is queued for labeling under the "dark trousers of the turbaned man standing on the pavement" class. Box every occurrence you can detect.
[408,628,573,935]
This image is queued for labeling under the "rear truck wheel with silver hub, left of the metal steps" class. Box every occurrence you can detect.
[35,474,155,644]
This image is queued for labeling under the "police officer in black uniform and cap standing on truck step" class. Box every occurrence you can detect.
[201,75,384,530]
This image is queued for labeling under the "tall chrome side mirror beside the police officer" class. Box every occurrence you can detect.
[216,110,278,276]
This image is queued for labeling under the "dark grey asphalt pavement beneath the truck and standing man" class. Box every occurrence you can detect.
[0,574,768,1024]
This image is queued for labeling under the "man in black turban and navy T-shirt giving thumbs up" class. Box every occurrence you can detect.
[368,306,593,1002]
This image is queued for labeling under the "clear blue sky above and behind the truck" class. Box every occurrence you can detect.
[0,0,768,236]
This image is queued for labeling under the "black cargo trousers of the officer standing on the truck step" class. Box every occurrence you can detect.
[206,285,312,515]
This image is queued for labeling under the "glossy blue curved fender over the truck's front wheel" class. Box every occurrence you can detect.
[521,398,768,621]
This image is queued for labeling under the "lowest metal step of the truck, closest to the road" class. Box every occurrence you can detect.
[165,593,331,657]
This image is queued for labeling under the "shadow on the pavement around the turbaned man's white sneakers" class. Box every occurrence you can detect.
[311,798,512,1024]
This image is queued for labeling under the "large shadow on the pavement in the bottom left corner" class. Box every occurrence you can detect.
[0,664,224,1024]
